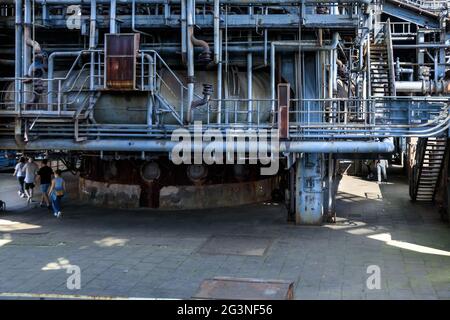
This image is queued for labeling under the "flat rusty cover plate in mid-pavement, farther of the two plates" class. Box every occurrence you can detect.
[198,235,272,256]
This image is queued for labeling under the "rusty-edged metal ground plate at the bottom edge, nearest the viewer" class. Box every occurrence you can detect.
[192,277,294,300]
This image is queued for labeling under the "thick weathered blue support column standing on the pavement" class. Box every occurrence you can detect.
[295,153,325,225]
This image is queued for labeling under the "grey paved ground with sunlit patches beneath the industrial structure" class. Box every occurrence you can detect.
[0,168,450,299]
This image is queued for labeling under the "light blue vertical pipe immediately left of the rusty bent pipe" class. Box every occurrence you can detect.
[186,0,195,123]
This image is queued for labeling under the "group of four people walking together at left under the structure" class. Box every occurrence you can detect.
[14,157,66,218]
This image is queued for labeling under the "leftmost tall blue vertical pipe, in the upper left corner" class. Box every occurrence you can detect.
[14,0,23,112]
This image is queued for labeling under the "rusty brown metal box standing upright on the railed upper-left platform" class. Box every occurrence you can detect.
[105,34,139,90]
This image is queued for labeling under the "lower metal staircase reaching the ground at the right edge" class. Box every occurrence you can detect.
[412,137,447,201]
